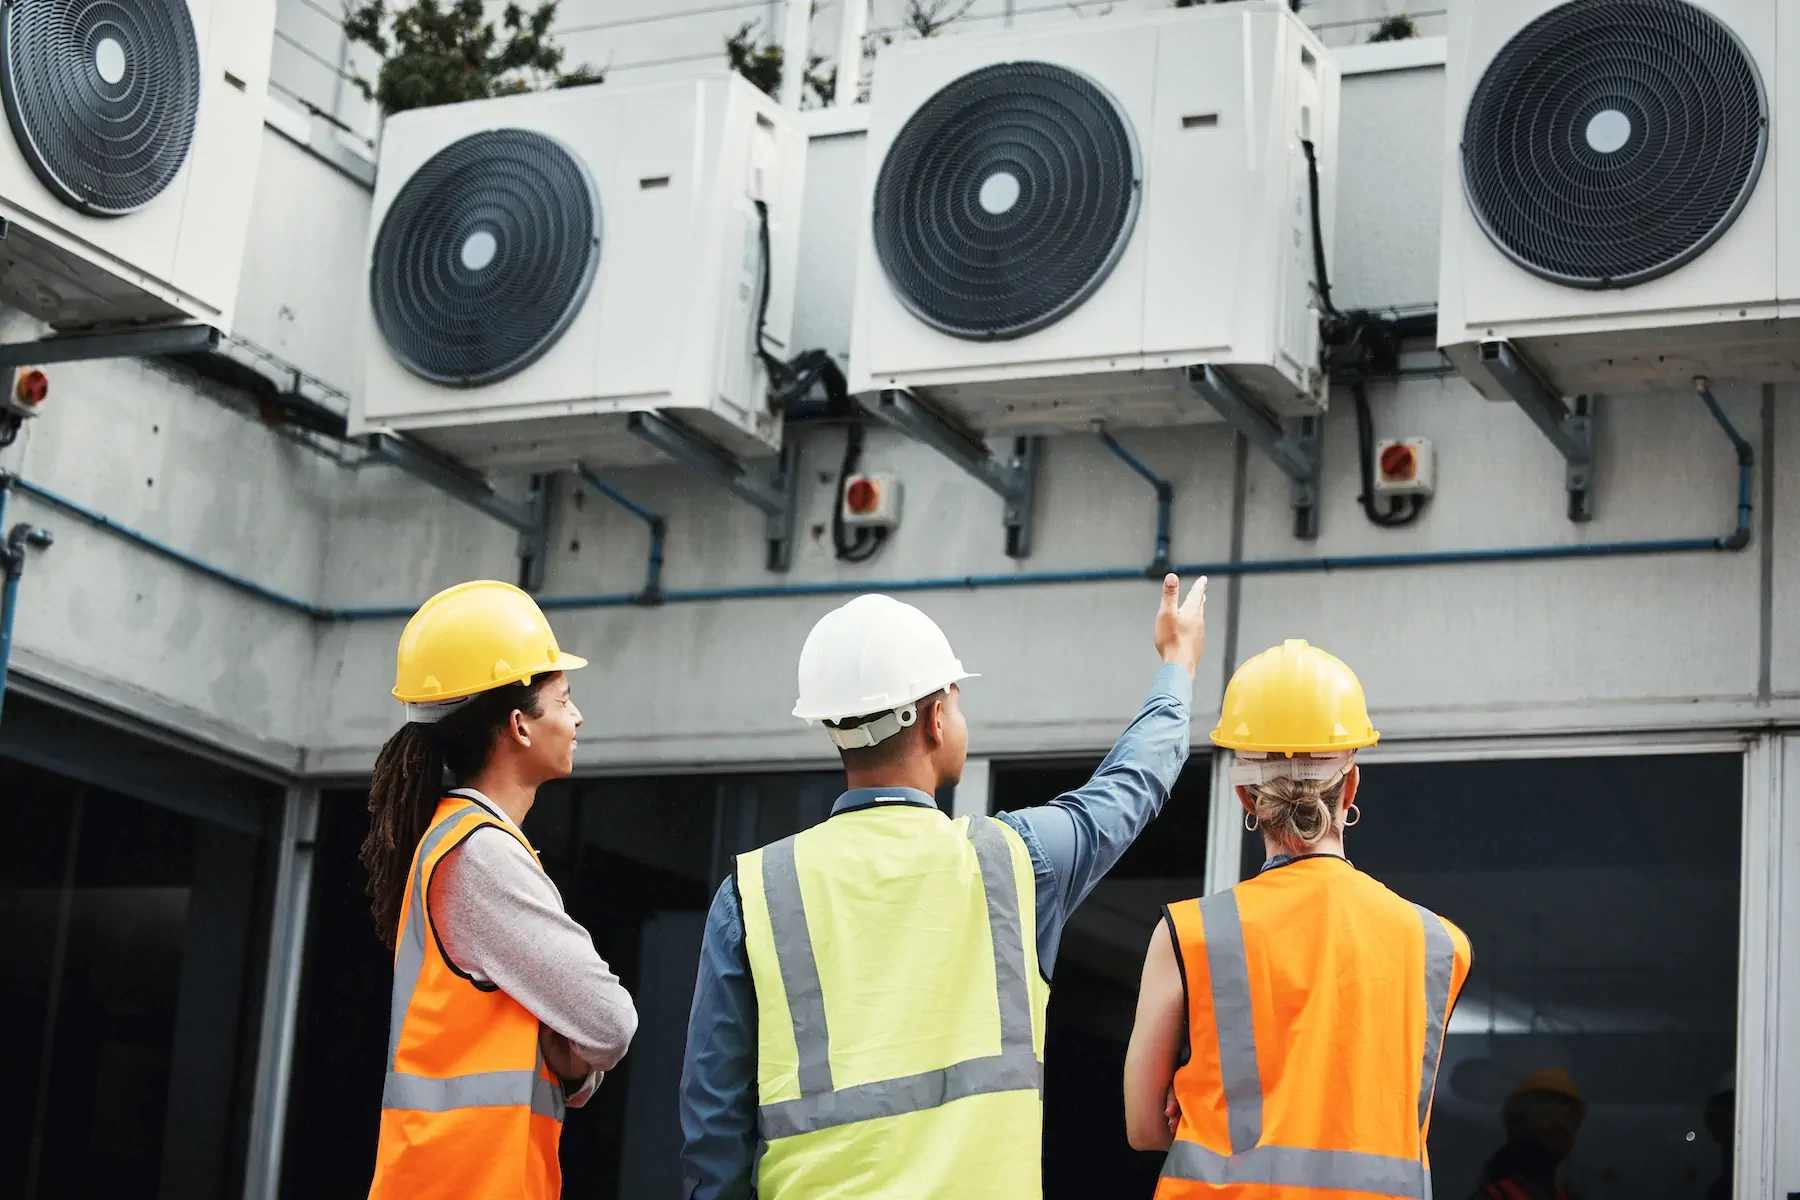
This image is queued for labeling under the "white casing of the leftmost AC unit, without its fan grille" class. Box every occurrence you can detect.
[0,0,275,331]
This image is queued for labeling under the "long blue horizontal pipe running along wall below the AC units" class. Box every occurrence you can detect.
[0,392,1755,621]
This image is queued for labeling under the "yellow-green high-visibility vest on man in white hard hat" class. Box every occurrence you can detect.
[738,804,1049,1200]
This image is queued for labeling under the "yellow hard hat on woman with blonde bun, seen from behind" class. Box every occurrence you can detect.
[1213,639,1381,754]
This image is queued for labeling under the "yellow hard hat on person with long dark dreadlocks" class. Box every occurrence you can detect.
[394,579,587,703]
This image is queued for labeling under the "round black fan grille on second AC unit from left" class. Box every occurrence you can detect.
[369,130,599,387]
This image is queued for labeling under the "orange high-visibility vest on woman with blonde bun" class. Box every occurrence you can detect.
[1156,858,1469,1200]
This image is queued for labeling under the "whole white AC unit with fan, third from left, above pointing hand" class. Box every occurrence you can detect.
[850,0,1339,434]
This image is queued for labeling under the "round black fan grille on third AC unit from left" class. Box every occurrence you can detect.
[875,63,1139,340]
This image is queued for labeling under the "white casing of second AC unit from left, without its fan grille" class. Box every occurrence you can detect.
[351,72,806,470]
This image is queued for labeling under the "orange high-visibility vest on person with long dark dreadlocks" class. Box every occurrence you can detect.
[369,795,563,1200]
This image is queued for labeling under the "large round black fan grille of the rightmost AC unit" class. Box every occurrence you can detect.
[1462,0,1769,288]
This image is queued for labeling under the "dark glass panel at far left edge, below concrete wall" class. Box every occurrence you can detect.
[0,752,279,1200]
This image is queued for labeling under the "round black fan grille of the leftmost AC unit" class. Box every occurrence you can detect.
[0,0,200,216]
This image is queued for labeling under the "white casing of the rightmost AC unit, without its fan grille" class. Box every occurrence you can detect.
[1438,0,1800,399]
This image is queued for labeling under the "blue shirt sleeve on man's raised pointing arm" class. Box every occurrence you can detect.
[999,664,1193,977]
